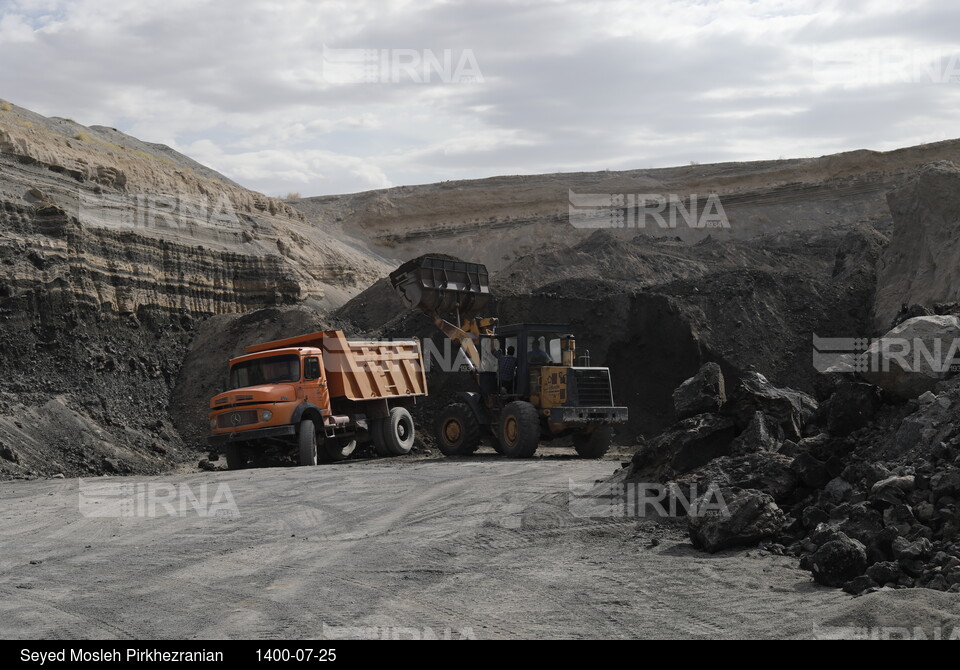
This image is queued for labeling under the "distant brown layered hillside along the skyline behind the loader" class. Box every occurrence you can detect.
[290,141,960,270]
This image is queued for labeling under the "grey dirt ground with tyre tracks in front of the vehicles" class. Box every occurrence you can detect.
[0,452,872,639]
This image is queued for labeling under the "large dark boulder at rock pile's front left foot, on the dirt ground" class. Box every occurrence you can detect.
[687,488,786,554]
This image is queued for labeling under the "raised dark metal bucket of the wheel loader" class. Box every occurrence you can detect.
[390,256,490,314]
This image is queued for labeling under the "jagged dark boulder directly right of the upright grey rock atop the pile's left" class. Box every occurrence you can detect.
[723,371,819,440]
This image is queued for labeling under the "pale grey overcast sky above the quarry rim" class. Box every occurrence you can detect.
[0,0,960,196]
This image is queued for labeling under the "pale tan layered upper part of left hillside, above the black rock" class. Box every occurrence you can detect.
[0,104,387,314]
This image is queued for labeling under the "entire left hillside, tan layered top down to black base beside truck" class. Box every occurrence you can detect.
[0,101,389,476]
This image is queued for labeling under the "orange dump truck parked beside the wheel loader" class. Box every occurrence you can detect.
[209,330,427,470]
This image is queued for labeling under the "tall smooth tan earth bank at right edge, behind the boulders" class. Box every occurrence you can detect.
[874,161,960,329]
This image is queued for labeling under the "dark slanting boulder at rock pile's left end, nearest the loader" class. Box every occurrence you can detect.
[630,414,736,482]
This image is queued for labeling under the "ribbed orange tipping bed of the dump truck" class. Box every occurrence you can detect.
[246,330,427,400]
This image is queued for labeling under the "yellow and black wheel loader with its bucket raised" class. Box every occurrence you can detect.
[390,256,627,458]
